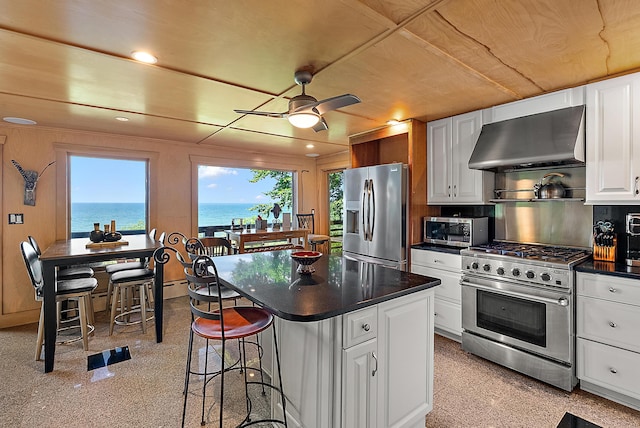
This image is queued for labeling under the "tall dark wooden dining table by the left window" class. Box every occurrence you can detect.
[40,234,164,373]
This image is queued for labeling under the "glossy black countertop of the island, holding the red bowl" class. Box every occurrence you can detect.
[213,250,440,321]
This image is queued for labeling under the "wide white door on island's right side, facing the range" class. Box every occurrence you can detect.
[377,289,433,428]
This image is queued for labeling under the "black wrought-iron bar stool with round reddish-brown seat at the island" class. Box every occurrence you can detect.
[182,256,287,427]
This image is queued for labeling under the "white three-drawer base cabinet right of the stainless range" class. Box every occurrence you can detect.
[576,272,640,410]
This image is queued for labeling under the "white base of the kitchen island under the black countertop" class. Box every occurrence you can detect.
[265,287,437,428]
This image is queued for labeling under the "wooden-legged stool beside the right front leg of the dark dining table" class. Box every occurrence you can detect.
[109,269,155,336]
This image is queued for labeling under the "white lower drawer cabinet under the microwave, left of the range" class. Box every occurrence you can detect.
[411,248,462,341]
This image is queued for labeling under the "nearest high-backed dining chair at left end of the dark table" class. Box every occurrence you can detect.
[20,241,98,361]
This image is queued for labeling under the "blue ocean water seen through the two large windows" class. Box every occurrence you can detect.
[71,202,276,233]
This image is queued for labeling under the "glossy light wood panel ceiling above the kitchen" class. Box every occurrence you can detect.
[0,0,640,155]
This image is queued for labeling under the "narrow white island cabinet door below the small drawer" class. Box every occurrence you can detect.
[342,339,378,428]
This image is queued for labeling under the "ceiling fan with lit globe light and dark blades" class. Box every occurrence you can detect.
[234,70,360,132]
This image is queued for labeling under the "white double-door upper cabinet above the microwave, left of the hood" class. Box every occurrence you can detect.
[427,111,494,205]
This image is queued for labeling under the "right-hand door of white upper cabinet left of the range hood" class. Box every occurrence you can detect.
[451,111,484,203]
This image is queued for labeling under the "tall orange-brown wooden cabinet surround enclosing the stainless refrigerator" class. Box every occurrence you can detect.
[349,119,440,245]
